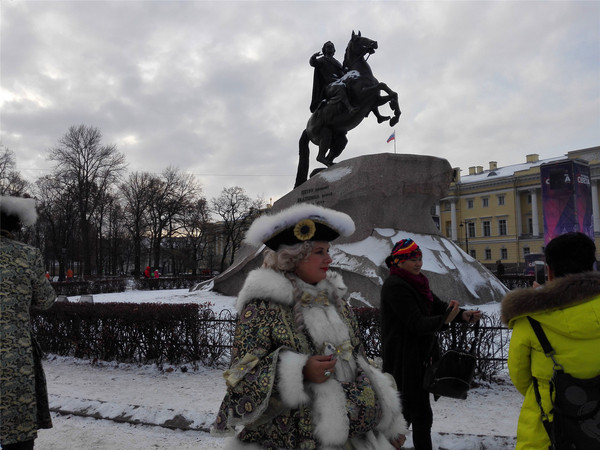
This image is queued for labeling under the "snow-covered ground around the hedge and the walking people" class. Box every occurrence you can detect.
[36,289,522,450]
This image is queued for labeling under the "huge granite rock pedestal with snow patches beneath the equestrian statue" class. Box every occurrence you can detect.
[199,153,507,307]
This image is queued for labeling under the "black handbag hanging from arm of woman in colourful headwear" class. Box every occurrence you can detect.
[423,311,479,400]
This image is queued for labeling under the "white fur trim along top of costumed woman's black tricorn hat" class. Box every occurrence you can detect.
[245,203,355,247]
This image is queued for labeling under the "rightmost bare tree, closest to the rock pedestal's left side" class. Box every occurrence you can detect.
[211,186,264,271]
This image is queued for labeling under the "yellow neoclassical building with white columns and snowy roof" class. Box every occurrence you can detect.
[436,146,600,272]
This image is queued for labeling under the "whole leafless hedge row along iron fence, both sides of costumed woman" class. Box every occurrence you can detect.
[32,303,510,380]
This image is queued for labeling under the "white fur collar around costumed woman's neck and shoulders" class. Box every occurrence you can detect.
[236,267,346,314]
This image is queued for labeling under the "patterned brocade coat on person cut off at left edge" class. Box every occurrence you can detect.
[0,236,56,445]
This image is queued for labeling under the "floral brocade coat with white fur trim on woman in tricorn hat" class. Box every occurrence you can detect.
[212,268,407,450]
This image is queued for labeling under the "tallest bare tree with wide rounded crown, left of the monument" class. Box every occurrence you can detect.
[49,125,125,276]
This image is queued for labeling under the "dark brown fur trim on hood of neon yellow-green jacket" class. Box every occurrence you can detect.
[500,272,600,324]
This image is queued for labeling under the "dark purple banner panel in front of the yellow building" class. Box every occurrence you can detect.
[540,160,594,244]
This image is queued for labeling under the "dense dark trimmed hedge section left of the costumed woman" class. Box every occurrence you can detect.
[32,303,211,364]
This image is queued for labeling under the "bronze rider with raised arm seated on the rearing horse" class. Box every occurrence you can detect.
[309,41,359,114]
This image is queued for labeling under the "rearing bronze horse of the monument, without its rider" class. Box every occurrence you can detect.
[294,31,400,188]
